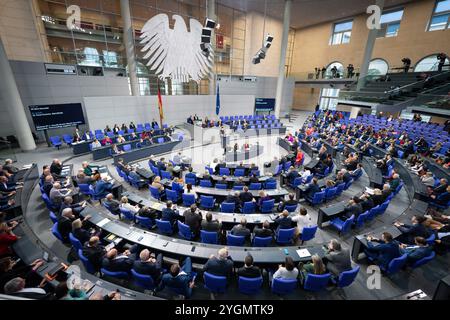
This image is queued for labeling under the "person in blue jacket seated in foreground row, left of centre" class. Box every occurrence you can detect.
[156,257,195,299]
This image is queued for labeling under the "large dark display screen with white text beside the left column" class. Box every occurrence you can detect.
[28,103,85,131]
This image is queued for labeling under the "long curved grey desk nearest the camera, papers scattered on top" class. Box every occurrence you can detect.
[81,207,325,267]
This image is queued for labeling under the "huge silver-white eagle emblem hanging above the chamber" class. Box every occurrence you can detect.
[141,13,214,82]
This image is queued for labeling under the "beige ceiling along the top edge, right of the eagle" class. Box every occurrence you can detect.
[217,0,423,29]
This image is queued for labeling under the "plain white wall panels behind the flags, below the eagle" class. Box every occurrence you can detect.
[83,94,255,130]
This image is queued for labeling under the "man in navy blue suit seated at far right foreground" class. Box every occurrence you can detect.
[365,232,401,268]
